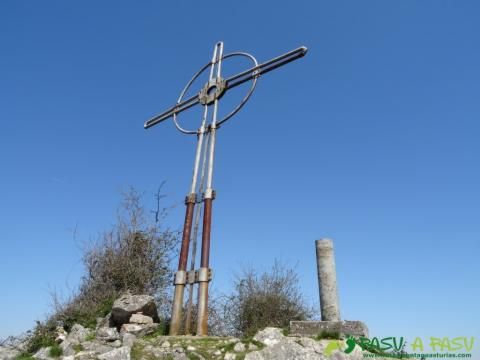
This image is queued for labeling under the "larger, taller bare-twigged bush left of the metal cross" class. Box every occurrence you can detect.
[24,189,178,353]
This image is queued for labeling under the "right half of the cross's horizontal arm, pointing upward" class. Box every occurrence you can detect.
[226,46,308,89]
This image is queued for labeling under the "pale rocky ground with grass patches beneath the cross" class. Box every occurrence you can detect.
[0,295,398,360]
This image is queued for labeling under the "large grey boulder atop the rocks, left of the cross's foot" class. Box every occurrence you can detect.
[111,294,159,328]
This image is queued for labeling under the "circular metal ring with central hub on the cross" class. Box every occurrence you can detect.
[173,52,258,134]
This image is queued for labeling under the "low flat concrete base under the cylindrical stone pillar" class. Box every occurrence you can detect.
[290,321,368,339]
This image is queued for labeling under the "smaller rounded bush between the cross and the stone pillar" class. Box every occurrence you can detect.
[225,261,313,337]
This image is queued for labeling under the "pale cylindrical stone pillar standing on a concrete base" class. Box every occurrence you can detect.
[315,239,340,321]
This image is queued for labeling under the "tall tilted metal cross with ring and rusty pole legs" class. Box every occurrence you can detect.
[144,42,307,335]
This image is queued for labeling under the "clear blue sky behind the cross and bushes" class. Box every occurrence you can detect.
[0,0,480,352]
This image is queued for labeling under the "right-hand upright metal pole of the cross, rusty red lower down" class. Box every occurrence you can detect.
[197,42,223,336]
